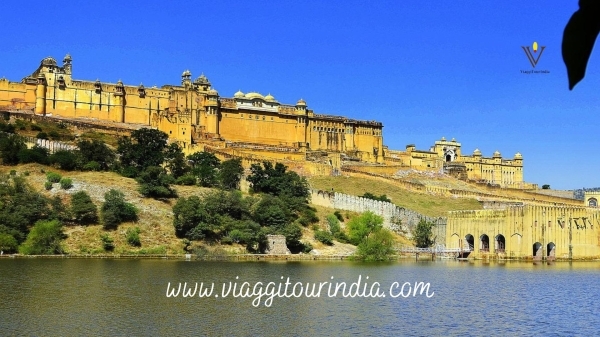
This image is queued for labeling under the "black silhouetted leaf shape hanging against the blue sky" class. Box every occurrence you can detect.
[562,0,600,90]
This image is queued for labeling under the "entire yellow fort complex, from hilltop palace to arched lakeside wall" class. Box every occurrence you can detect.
[0,55,600,259]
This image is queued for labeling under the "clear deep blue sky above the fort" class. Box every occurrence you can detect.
[0,0,600,189]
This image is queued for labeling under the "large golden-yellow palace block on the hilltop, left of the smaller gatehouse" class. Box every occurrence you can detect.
[0,55,383,163]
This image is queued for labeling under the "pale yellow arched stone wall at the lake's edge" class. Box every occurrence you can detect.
[446,205,600,260]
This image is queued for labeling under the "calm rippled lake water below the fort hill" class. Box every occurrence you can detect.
[0,258,600,336]
